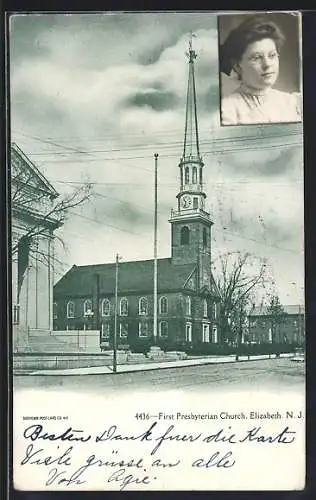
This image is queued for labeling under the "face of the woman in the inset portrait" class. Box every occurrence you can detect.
[236,38,279,90]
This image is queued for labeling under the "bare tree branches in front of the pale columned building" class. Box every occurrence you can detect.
[11,146,92,294]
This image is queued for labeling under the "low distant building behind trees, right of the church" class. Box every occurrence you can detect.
[248,305,305,345]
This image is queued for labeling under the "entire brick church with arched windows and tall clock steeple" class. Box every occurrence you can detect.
[53,40,220,351]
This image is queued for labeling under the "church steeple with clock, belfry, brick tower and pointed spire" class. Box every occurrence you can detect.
[169,33,213,275]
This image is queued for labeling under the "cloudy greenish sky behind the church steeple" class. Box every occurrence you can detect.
[10,12,304,304]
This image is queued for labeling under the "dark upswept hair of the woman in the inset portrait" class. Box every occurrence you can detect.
[220,16,285,76]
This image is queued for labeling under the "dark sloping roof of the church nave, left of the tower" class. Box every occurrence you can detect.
[54,258,196,298]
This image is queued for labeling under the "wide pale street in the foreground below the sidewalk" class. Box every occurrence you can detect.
[13,358,305,393]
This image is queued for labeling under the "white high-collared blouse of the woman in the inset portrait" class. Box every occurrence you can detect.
[221,88,302,125]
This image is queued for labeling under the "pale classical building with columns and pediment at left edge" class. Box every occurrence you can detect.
[10,143,60,350]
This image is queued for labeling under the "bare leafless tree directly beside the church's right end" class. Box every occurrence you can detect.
[213,252,266,343]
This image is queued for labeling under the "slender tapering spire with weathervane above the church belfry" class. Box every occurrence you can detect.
[183,32,201,160]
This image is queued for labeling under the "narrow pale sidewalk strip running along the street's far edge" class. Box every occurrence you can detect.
[15,353,294,376]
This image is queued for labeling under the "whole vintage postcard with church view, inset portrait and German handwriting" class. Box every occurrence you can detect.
[7,11,306,491]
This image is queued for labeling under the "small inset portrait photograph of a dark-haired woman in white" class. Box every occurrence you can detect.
[218,12,302,125]
